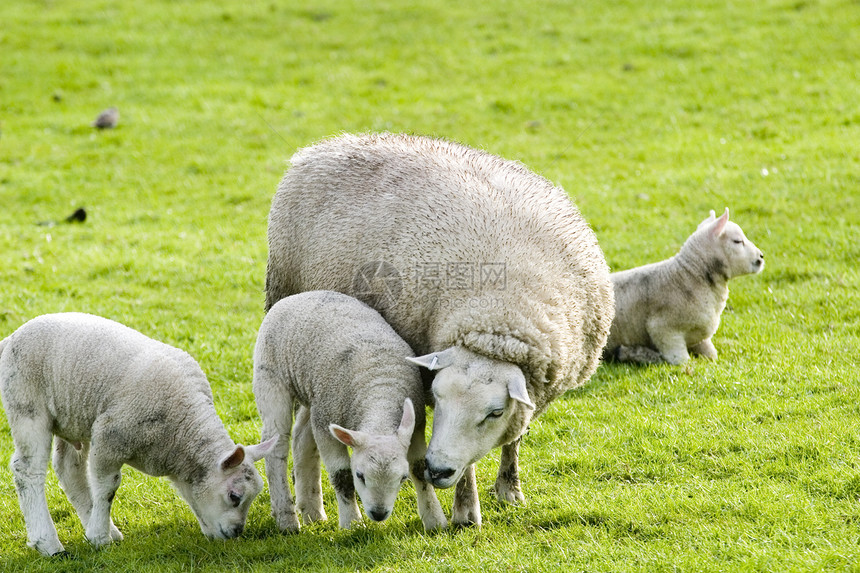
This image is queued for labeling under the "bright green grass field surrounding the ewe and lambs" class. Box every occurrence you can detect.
[0,0,860,571]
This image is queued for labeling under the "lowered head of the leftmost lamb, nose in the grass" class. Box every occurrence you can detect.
[173,438,277,539]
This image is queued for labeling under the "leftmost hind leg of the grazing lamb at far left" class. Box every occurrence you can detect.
[9,416,63,555]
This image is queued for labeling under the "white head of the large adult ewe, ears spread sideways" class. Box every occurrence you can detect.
[409,347,535,488]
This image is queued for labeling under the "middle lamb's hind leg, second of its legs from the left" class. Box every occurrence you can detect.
[293,406,327,523]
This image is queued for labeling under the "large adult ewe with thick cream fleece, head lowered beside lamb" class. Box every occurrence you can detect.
[266,134,613,525]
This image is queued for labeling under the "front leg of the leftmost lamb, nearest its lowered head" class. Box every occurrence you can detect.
[85,444,122,547]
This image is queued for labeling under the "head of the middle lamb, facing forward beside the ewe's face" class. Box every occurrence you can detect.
[329,398,415,521]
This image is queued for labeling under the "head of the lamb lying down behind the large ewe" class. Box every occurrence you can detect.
[693,207,764,280]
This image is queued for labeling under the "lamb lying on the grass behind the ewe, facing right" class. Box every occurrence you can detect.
[604,207,764,364]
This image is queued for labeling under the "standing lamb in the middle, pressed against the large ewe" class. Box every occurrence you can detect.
[254,291,447,531]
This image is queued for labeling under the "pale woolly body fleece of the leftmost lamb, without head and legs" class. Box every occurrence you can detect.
[0,313,228,480]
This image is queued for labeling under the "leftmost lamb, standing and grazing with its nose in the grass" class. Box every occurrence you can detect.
[0,313,273,555]
